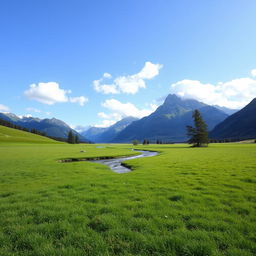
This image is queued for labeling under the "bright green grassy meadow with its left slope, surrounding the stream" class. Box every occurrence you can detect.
[0,126,256,256]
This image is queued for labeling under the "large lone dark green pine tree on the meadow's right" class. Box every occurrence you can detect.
[187,110,209,147]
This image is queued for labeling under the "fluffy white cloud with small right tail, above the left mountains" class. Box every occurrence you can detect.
[24,82,88,106]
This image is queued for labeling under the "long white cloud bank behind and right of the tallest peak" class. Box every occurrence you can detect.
[171,78,256,109]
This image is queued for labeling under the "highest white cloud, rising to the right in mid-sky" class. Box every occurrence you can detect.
[93,61,162,94]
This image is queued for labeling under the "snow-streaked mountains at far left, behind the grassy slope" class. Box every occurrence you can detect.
[0,113,86,141]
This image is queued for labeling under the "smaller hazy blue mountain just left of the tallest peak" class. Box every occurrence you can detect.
[82,116,138,143]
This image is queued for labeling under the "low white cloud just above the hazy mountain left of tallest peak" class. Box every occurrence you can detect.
[102,99,156,118]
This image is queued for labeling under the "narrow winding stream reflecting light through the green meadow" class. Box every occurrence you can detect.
[90,150,159,173]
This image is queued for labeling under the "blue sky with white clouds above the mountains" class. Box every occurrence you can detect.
[0,0,256,129]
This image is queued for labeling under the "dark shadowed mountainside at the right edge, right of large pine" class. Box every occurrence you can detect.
[210,98,256,139]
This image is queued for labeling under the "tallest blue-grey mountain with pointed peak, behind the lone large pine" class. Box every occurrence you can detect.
[112,94,228,142]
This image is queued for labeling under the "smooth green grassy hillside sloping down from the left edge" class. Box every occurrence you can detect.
[0,125,60,144]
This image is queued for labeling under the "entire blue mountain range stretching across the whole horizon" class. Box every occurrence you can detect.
[0,94,256,143]
